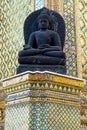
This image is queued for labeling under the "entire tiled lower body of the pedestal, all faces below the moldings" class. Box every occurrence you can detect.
[5,102,80,130]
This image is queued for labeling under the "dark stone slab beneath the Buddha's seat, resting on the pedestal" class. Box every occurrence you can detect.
[17,64,66,74]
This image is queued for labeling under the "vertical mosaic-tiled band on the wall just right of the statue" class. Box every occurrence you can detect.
[63,0,77,76]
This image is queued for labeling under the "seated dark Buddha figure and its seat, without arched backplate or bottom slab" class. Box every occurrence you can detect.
[18,7,65,74]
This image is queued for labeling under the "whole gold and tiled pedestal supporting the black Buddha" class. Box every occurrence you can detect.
[2,72,83,130]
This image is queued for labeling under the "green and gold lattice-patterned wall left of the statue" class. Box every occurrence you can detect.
[0,0,34,79]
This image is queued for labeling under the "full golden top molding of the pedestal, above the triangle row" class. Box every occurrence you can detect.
[2,72,84,88]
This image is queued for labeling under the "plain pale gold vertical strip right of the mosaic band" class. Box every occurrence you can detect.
[75,0,82,78]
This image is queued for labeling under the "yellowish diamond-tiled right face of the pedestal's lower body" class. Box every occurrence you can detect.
[47,103,80,130]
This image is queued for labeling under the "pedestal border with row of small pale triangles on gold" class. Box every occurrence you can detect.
[5,81,82,95]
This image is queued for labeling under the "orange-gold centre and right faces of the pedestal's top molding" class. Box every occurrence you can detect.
[29,73,84,87]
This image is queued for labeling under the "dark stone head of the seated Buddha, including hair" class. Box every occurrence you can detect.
[38,14,50,30]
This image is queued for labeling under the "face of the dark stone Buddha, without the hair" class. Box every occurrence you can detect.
[38,18,49,30]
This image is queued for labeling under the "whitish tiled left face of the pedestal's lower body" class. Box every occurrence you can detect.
[5,104,31,130]
